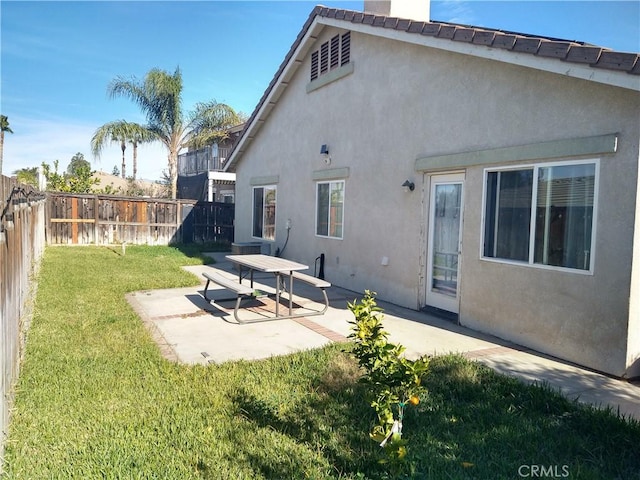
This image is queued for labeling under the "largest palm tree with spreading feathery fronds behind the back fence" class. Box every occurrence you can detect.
[108,68,242,199]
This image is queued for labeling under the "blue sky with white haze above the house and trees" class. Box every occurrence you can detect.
[0,0,640,180]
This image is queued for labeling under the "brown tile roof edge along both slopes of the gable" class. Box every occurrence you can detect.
[228,5,640,166]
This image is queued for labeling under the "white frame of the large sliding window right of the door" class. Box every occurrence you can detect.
[479,158,600,276]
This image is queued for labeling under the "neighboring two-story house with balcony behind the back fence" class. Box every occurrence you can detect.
[178,124,244,203]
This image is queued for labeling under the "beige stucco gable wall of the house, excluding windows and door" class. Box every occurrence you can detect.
[236,29,640,375]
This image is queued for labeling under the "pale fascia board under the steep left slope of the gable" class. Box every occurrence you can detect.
[225,19,324,171]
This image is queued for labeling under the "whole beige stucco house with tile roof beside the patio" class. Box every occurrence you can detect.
[226,2,640,376]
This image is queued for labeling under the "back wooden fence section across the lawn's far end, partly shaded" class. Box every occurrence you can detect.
[46,193,234,245]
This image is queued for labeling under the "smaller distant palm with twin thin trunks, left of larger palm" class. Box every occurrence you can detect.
[91,120,155,180]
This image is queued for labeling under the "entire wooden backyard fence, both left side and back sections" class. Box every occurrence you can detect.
[0,188,234,468]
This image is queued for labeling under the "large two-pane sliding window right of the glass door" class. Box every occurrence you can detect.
[483,161,597,270]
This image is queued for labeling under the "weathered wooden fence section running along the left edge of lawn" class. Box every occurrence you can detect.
[0,175,45,473]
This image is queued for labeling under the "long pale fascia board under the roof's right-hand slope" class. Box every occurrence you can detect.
[316,17,640,91]
